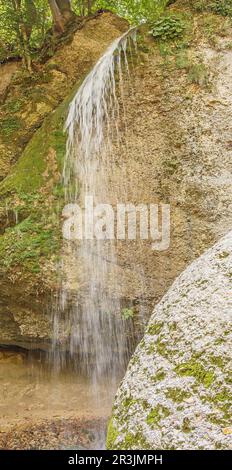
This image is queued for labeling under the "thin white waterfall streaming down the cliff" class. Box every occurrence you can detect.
[54,29,136,386]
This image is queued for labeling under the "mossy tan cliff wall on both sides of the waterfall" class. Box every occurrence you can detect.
[0,2,232,344]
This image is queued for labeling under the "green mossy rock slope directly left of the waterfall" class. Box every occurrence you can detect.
[0,81,82,280]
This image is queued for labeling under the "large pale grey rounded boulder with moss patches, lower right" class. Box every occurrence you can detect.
[108,231,232,449]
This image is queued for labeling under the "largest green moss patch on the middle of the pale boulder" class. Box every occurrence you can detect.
[175,360,214,388]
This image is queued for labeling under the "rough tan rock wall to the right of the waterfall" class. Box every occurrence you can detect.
[89,2,232,319]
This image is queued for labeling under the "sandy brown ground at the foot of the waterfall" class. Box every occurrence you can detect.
[0,351,114,449]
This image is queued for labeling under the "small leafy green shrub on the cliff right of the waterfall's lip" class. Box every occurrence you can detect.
[151,15,186,41]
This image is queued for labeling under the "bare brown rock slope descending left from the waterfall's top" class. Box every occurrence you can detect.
[0,13,128,180]
